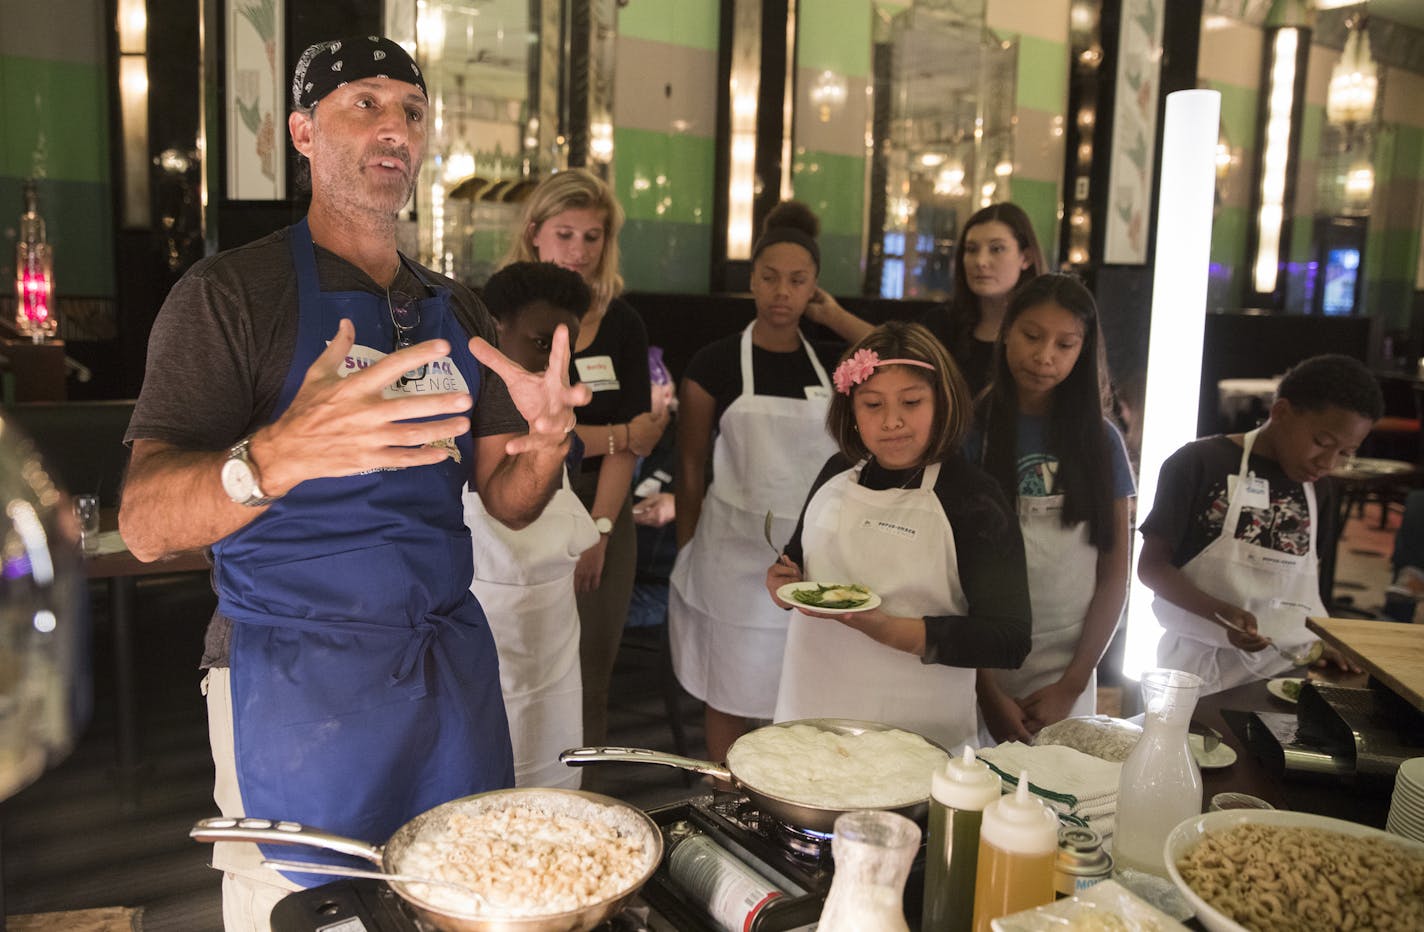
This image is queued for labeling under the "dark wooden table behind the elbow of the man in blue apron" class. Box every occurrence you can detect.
[84,532,211,809]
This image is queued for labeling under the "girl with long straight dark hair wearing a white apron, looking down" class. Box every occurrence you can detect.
[970,275,1135,741]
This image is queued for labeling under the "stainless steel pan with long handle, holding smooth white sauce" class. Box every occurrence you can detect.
[558,718,948,832]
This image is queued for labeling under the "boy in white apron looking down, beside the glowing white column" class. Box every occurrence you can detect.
[1138,355,1384,694]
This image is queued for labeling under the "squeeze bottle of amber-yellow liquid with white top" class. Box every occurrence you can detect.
[974,770,1058,932]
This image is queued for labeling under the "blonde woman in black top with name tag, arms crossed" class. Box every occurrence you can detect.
[501,168,668,744]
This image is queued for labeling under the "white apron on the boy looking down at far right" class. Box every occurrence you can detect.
[1152,428,1326,695]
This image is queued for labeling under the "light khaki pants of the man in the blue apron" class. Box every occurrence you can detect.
[202,667,302,932]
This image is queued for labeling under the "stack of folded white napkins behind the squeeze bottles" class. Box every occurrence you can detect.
[978,741,1122,841]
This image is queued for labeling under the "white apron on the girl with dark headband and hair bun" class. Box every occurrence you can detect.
[668,325,836,718]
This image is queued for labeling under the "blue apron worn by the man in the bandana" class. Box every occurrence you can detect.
[212,219,514,885]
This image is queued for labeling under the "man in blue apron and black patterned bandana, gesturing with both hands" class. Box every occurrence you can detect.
[120,37,587,929]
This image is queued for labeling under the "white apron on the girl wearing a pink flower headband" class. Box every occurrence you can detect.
[776,462,977,748]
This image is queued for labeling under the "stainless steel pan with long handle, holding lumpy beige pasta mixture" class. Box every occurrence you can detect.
[188,789,662,932]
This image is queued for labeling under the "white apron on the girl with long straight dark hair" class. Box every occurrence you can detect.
[995,495,1098,715]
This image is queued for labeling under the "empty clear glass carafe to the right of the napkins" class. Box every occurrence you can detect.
[1112,670,1202,876]
